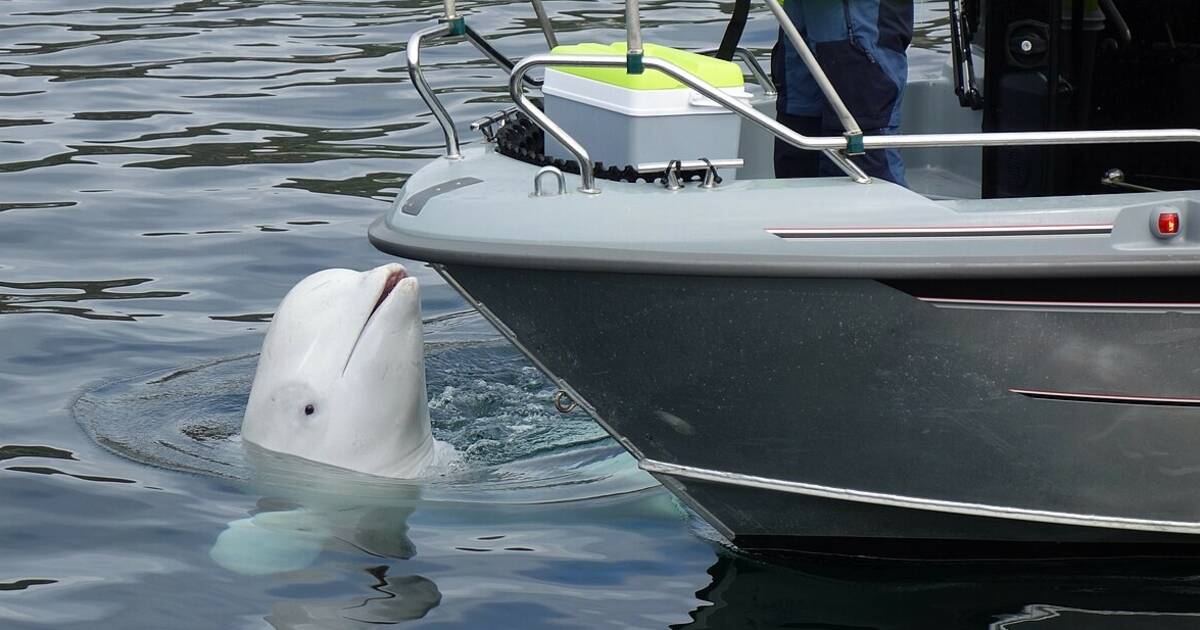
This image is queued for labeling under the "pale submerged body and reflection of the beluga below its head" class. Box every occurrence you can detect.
[209,445,442,629]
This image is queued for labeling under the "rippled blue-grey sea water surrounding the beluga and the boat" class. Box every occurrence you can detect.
[7,0,1200,629]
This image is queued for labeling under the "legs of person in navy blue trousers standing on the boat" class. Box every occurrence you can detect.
[770,0,913,186]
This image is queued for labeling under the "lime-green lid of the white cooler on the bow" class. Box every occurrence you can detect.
[550,42,745,90]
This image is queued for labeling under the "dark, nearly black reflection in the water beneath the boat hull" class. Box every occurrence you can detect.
[672,551,1200,630]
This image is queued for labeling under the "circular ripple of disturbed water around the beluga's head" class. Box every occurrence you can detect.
[72,328,656,503]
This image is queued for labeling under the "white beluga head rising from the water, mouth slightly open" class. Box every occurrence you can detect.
[241,264,434,478]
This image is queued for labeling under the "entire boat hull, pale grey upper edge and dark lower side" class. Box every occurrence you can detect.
[368,146,1200,548]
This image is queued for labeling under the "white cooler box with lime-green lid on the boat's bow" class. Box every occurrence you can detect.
[541,42,750,179]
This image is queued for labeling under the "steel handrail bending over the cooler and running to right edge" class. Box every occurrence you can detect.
[509,55,1200,188]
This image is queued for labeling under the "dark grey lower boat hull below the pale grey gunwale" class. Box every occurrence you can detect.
[438,264,1200,548]
